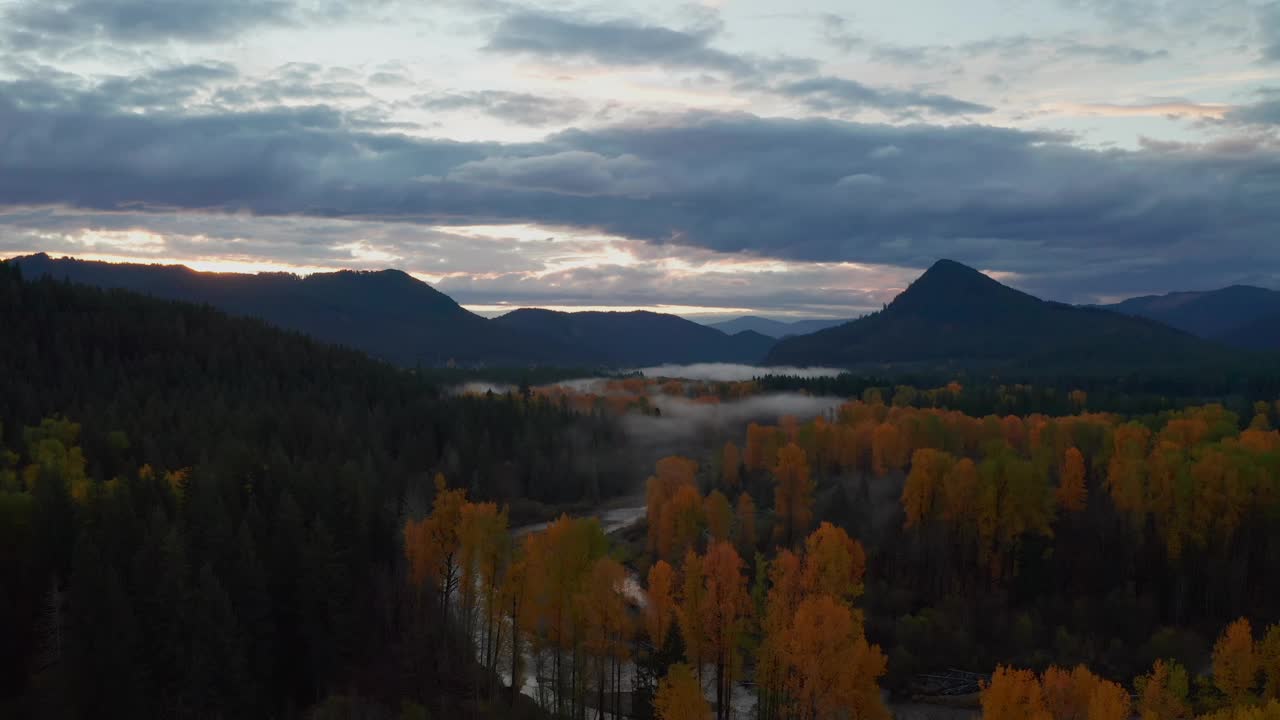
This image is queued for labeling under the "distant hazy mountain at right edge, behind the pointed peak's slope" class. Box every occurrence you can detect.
[1102,284,1280,347]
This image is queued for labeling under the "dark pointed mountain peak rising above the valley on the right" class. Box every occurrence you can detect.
[767,260,1228,372]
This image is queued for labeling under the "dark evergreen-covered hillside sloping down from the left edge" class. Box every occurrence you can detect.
[0,264,634,717]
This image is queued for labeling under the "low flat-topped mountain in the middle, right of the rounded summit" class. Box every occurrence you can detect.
[494,309,773,366]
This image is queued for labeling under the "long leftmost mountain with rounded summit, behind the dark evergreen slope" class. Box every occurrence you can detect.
[5,254,583,366]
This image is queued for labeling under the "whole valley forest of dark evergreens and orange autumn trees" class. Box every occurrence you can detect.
[0,258,1280,720]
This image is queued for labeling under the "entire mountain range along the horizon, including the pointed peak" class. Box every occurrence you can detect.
[14,254,1280,372]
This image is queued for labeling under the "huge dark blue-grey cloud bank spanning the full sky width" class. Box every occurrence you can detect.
[0,73,1280,292]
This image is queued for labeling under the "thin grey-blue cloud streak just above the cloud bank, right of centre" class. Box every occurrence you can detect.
[777,77,992,115]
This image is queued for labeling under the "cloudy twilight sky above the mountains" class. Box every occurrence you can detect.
[0,0,1280,319]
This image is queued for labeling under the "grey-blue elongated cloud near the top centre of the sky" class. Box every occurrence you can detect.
[486,13,815,78]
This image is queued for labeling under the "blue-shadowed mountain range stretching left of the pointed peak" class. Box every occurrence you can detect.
[13,254,773,366]
